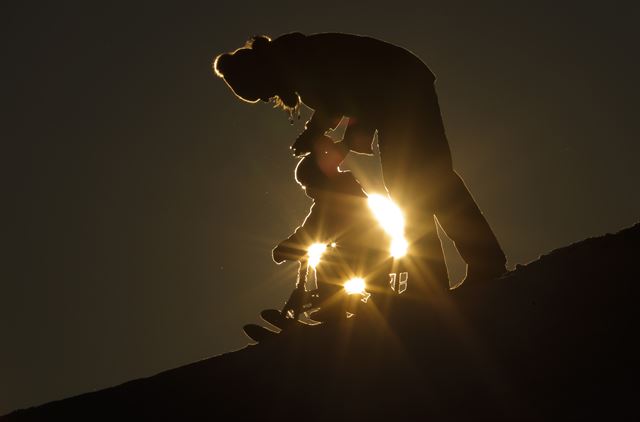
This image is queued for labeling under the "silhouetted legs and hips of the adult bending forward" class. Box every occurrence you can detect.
[378,88,506,290]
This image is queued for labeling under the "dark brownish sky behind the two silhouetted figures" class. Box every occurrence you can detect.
[0,1,640,414]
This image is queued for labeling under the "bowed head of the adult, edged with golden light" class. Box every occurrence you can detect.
[213,35,300,110]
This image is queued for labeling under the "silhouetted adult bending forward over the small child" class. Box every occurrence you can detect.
[214,33,506,290]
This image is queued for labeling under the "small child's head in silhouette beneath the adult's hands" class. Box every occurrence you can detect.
[295,137,357,198]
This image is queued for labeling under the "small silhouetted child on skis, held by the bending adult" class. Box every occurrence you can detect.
[273,137,390,320]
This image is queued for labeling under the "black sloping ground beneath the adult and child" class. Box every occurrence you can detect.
[2,224,640,421]
